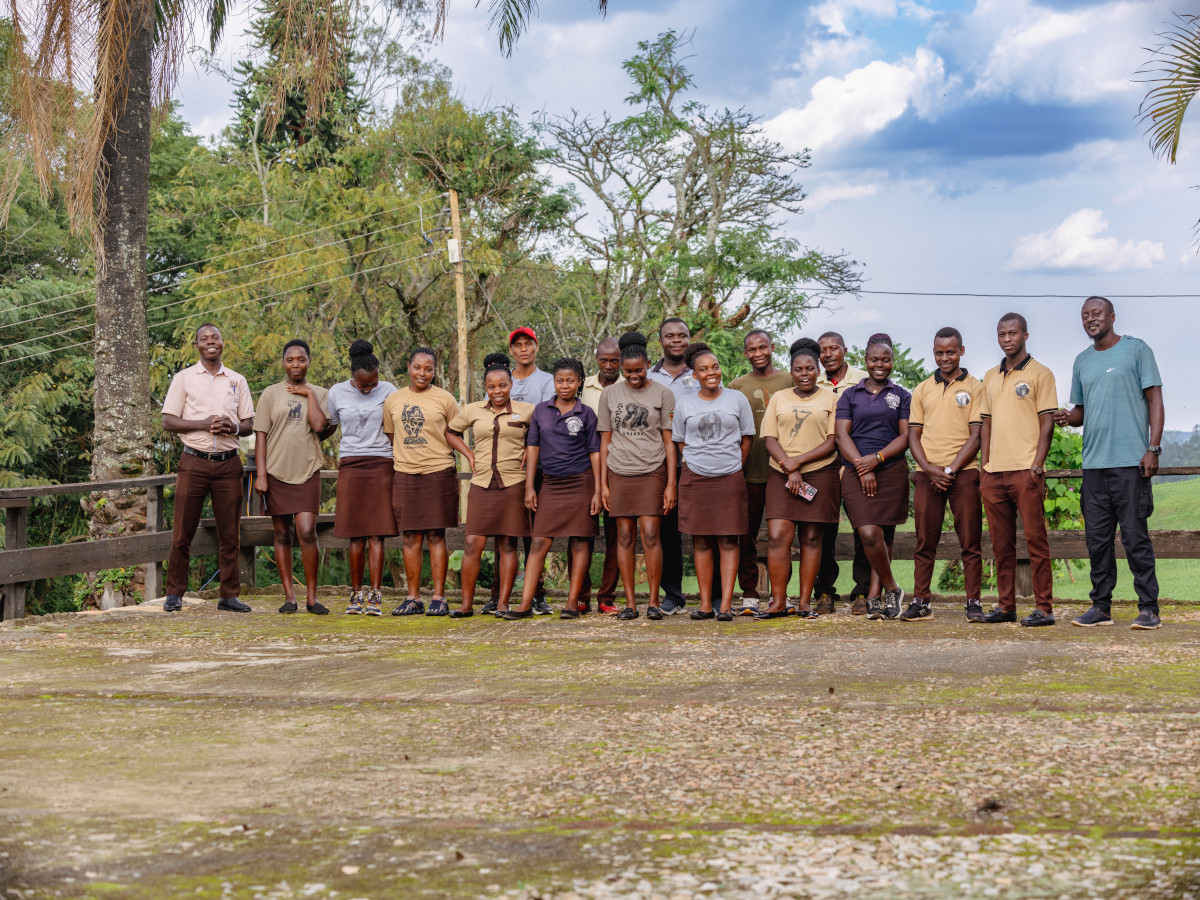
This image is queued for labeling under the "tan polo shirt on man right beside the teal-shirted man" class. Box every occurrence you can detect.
[983,356,1058,472]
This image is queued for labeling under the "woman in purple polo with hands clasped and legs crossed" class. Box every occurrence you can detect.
[836,335,912,619]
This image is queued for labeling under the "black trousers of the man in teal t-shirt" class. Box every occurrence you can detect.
[1082,466,1158,613]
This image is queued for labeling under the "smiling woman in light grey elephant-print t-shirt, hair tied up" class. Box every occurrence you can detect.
[672,343,755,622]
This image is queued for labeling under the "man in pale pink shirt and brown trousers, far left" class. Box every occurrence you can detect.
[162,324,254,612]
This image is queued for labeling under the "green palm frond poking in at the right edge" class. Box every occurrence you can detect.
[1138,13,1200,163]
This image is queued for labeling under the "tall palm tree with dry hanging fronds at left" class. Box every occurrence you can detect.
[0,0,349,547]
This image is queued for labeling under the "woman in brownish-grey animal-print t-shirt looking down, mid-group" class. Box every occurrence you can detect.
[596,331,676,619]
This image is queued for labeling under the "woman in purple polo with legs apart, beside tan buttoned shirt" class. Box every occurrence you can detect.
[500,358,600,619]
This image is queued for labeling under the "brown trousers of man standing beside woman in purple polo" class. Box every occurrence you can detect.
[912,469,983,600]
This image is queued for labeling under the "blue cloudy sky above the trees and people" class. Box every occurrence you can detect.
[178,0,1200,430]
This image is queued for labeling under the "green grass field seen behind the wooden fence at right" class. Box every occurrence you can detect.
[684,479,1200,601]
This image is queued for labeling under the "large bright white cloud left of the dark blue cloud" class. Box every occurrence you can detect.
[766,48,947,150]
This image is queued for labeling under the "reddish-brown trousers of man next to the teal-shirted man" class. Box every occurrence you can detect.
[979,469,1054,612]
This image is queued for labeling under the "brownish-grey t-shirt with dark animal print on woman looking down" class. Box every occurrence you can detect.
[596,380,676,475]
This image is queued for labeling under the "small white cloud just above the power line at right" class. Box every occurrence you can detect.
[1008,209,1166,272]
